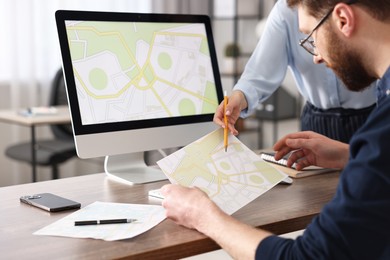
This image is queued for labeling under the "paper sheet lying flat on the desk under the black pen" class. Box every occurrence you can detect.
[34,201,165,241]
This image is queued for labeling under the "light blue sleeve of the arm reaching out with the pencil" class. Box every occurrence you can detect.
[234,1,293,117]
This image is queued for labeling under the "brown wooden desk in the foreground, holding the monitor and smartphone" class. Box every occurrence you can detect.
[0,173,339,259]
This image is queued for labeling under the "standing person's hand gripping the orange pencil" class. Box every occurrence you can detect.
[214,90,248,135]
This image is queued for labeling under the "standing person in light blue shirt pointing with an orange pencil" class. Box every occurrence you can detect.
[214,0,376,143]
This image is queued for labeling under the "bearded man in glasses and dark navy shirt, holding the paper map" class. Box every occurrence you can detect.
[162,0,390,259]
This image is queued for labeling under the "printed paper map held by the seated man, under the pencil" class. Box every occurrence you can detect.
[157,129,287,214]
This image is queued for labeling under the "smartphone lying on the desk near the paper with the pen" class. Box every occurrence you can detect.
[20,193,81,212]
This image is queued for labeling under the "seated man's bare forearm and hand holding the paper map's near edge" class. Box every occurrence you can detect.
[161,184,271,259]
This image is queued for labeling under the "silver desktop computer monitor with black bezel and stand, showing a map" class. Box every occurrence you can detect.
[56,10,223,183]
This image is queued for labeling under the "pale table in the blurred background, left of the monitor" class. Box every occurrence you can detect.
[0,106,70,182]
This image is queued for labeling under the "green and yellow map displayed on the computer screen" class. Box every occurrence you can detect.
[66,21,218,125]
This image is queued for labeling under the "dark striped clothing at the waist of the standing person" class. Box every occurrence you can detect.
[301,102,376,143]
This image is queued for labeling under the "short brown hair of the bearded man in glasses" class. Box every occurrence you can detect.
[287,0,390,21]
